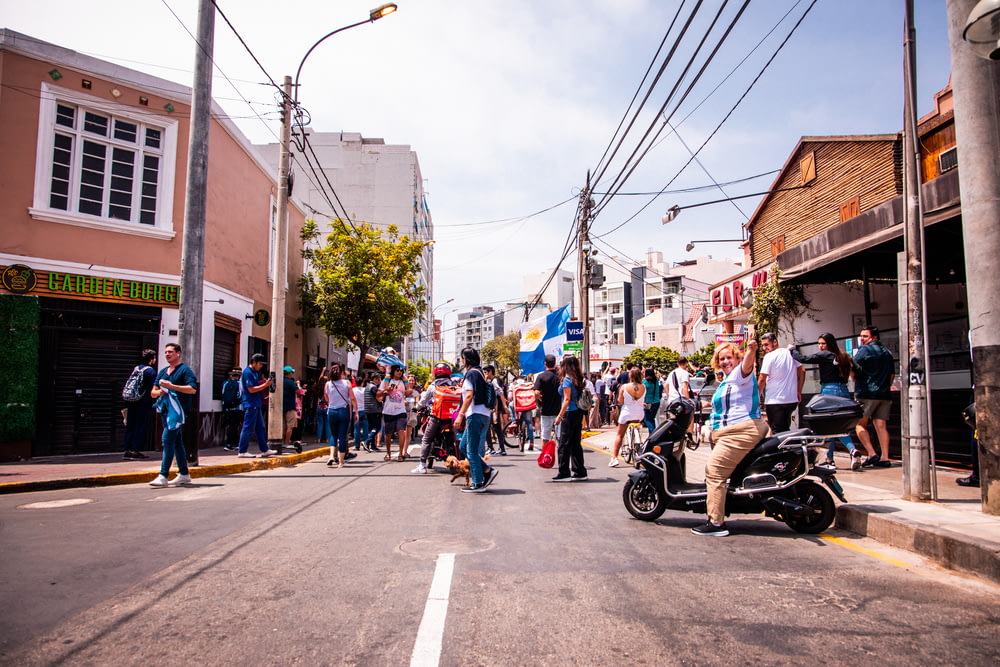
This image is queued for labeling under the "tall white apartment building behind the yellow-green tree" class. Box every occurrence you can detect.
[257,129,437,376]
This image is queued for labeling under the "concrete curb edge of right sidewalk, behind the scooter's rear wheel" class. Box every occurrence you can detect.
[836,505,1000,584]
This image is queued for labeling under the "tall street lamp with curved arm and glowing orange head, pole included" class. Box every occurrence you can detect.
[267,2,396,453]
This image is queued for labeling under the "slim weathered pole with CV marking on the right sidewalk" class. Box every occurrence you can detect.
[904,0,936,500]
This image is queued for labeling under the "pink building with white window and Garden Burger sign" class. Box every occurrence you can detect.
[0,30,304,459]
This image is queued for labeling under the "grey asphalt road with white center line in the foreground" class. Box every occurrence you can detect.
[0,452,1000,665]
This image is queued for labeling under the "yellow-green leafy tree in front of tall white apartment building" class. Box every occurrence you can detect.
[299,220,424,352]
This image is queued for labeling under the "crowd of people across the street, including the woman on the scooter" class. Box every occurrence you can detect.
[123,327,952,504]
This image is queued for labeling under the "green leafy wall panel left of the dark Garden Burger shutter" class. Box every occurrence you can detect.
[0,294,41,442]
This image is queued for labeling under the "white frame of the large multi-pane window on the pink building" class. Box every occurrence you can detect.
[28,82,179,240]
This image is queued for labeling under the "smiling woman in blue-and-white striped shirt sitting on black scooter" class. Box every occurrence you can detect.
[691,339,768,537]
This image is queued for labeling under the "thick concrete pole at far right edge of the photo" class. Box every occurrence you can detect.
[947,0,1000,515]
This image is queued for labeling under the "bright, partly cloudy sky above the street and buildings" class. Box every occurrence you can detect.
[0,0,950,344]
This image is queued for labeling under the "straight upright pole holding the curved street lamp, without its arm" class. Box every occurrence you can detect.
[267,76,293,451]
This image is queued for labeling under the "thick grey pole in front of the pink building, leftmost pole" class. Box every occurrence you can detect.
[177,0,215,465]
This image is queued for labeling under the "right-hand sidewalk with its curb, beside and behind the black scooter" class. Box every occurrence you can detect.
[584,429,1000,583]
